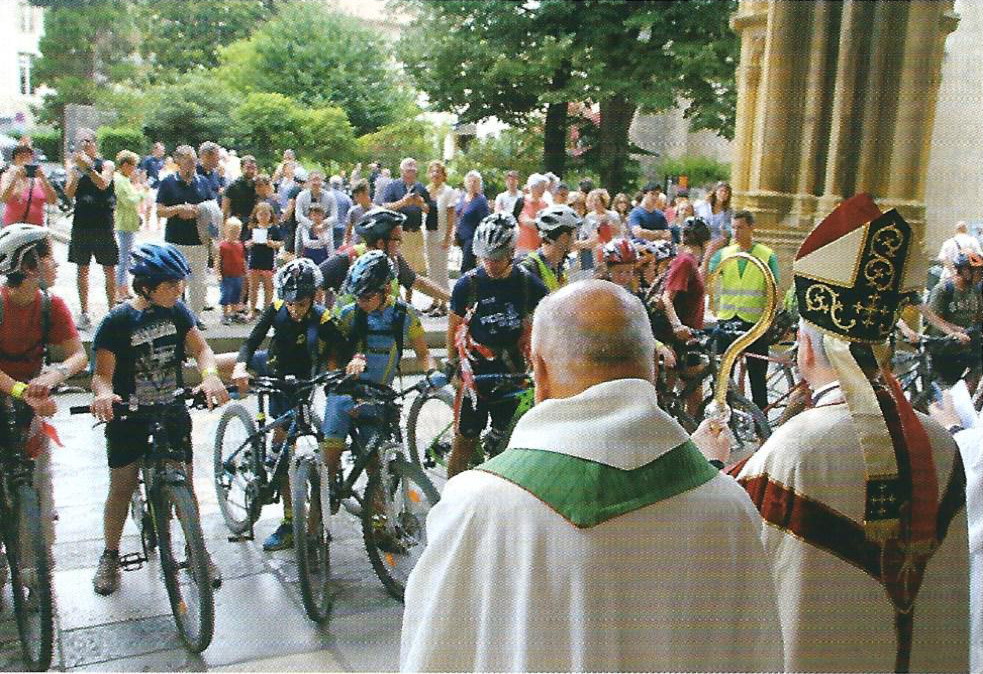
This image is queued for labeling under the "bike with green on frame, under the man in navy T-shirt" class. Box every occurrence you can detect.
[406,373,535,480]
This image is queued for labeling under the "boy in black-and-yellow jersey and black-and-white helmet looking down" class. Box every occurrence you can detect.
[216,258,339,552]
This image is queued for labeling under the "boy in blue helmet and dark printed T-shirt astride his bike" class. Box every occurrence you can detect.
[92,243,229,595]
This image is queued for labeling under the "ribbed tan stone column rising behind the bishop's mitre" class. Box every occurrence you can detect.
[731,0,957,286]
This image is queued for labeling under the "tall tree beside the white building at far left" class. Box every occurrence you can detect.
[34,0,139,123]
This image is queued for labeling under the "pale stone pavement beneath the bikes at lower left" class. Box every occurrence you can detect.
[0,386,402,671]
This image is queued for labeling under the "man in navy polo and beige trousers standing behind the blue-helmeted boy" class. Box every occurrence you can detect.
[157,145,212,316]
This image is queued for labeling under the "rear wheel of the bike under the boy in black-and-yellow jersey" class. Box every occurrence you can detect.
[214,405,262,535]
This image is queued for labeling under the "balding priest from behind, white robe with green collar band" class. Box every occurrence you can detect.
[401,281,782,671]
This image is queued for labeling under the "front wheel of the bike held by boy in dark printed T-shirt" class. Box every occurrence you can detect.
[152,483,215,653]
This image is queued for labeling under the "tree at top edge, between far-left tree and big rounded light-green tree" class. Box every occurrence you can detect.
[136,0,271,82]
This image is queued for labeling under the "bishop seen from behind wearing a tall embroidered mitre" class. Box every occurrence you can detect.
[734,195,969,672]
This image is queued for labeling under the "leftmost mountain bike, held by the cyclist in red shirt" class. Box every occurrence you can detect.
[0,396,54,671]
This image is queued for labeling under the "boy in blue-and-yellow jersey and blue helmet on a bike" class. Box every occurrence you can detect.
[321,250,434,490]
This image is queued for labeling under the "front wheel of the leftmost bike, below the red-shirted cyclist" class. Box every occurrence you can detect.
[6,484,54,672]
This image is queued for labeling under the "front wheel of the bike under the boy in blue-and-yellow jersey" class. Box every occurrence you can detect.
[362,452,440,601]
